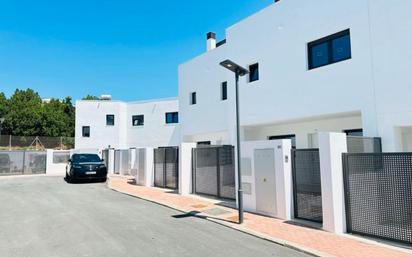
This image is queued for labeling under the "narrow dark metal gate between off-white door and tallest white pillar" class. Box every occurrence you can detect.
[292,149,323,222]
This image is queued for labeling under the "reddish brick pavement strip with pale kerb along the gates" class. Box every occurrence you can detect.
[108,176,412,257]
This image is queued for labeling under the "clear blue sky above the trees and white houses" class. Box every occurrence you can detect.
[0,0,273,101]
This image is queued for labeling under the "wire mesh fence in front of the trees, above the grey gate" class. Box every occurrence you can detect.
[0,135,74,150]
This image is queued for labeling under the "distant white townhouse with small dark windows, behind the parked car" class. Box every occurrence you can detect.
[75,98,180,150]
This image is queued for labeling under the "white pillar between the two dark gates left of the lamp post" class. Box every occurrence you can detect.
[179,143,196,195]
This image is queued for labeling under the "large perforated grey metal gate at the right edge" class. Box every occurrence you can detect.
[343,153,412,244]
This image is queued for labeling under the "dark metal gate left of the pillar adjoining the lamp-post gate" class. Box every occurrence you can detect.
[154,147,179,189]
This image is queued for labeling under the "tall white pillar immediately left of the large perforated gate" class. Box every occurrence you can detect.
[319,133,347,234]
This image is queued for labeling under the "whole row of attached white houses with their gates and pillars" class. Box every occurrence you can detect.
[75,0,412,243]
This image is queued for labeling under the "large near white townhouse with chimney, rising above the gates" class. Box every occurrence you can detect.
[179,0,412,151]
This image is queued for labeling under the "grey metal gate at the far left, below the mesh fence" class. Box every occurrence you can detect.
[0,151,47,176]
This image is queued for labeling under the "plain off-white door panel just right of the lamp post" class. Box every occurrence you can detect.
[254,149,277,216]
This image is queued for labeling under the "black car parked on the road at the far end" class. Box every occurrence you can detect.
[66,154,107,182]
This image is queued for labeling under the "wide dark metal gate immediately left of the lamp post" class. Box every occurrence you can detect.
[192,146,236,199]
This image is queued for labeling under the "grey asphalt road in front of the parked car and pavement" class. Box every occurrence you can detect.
[0,177,306,257]
